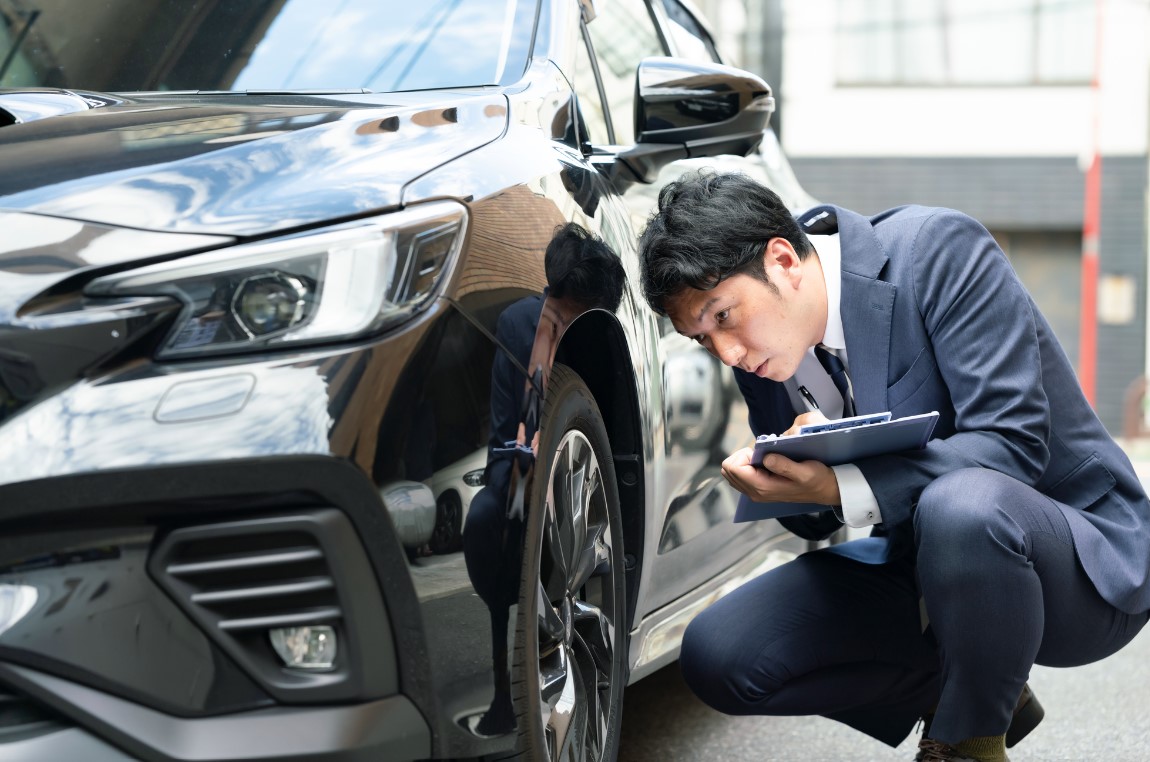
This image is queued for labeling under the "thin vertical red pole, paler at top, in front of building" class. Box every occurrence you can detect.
[1079,0,1105,406]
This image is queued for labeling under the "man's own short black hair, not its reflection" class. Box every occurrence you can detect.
[639,171,814,315]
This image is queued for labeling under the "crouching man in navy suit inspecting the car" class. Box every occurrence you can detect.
[641,174,1150,761]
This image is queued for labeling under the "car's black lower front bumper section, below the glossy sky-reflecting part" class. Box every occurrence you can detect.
[0,456,436,760]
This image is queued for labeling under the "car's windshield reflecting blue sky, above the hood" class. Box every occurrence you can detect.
[0,0,538,92]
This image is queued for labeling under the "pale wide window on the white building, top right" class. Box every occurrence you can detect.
[836,0,1095,85]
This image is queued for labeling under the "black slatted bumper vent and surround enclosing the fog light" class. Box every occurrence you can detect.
[148,508,394,703]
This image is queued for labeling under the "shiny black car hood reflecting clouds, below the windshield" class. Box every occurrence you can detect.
[0,91,507,237]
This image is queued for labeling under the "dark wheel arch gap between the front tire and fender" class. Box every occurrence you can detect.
[555,310,646,630]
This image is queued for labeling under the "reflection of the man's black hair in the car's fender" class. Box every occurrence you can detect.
[543,222,627,313]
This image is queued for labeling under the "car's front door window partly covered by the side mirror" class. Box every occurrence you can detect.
[588,0,666,145]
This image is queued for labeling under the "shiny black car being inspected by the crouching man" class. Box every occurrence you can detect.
[0,0,805,761]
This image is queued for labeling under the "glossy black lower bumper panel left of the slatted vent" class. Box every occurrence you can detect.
[0,529,273,716]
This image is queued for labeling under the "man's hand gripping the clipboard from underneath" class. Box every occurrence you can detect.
[722,448,842,506]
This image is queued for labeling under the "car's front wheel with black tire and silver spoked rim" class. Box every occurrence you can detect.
[512,364,627,762]
